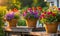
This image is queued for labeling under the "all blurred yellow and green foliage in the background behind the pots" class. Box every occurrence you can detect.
[0,0,49,36]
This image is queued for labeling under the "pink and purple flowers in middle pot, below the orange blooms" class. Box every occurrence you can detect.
[23,8,39,18]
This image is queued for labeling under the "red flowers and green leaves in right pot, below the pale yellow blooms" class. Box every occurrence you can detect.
[40,12,57,22]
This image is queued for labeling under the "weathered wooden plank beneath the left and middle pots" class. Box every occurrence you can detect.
[3,26,32,32]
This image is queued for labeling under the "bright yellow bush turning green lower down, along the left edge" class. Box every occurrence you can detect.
[0,6,7,36]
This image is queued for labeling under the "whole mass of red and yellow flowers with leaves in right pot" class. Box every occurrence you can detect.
[40,8,60,23]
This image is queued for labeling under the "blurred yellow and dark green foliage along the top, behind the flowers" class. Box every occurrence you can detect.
[7,0,48,9]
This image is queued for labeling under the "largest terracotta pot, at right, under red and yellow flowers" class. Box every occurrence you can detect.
[45,23,58,33]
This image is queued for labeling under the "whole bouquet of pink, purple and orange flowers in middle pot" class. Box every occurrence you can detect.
[23,7,41,19]
